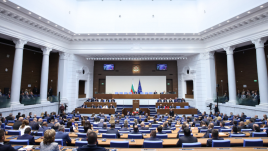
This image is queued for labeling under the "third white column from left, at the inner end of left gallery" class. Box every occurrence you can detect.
[58,52,70,103]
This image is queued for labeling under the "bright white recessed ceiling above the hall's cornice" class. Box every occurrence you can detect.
[7,0,268,33]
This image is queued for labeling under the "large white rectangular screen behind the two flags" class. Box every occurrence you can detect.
[105,76,166,94]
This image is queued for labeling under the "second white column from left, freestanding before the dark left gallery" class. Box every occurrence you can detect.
[40,47,52,103]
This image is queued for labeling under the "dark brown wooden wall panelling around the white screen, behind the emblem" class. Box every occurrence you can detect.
[93,61,178,93]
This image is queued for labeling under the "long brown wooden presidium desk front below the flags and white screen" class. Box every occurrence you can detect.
[93,94,178,99]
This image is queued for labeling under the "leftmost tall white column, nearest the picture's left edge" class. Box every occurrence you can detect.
[10,39,27,106]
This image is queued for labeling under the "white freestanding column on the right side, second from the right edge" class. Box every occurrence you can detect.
[223,46,236,104]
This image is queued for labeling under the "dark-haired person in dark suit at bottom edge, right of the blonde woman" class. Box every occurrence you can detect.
[77,132,106,151]
